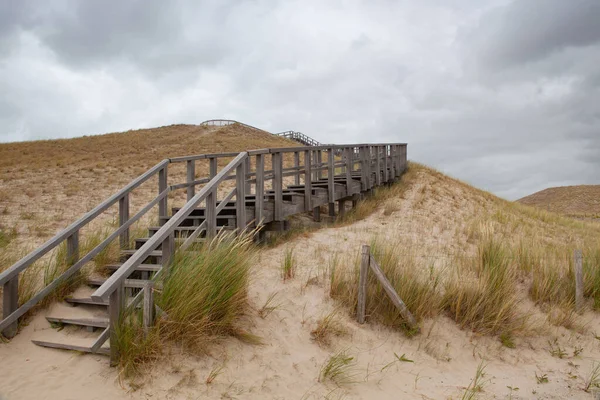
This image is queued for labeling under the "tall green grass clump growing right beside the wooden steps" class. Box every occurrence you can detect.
[117,233,257,376]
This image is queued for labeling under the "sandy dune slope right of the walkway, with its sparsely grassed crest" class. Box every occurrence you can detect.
[0,164,600,399]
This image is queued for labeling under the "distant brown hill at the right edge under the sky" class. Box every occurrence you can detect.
[517,185,600,218]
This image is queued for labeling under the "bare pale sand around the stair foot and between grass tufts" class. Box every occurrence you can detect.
[0,167,600,400]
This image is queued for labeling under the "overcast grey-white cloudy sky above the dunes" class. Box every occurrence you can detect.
[0,0,600,199]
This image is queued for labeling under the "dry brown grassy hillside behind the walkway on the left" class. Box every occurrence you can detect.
[0,125,298,247]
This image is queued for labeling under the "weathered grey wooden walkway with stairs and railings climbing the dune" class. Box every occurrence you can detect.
[0,143,407,360]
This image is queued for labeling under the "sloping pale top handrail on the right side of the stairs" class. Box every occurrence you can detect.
[91,152,248,301]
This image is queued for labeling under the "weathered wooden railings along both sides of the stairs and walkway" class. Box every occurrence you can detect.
[0,143,406,360]
